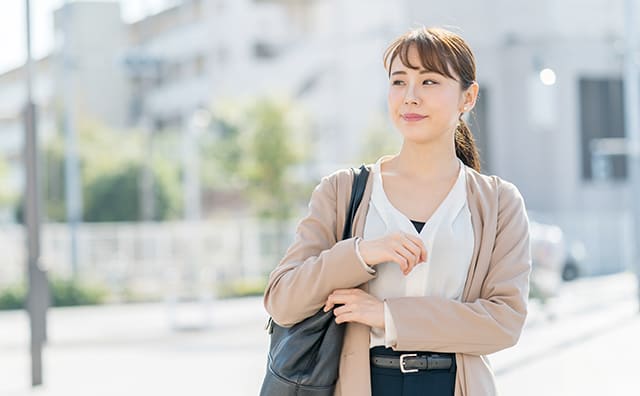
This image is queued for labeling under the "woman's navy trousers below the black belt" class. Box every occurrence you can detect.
[370,346,456,396]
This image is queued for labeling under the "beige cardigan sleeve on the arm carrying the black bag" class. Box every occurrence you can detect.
[264,173,375,326]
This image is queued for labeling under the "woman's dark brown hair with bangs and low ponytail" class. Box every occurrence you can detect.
[383,27,480,172]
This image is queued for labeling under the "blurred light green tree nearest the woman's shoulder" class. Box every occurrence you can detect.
[203,98,309,220]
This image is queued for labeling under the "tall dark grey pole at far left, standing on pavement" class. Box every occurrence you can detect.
[24,0,50,386]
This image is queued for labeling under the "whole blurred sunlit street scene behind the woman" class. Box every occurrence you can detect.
[0,0,640,396]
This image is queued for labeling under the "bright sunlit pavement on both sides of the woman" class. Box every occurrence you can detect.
[0,274,640,396]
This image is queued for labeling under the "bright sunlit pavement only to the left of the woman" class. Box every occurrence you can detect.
[0,298,268,396]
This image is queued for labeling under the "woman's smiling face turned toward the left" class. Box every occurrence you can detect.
[388,46,469,143]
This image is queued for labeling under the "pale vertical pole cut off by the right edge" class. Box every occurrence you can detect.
[624,0,640,312]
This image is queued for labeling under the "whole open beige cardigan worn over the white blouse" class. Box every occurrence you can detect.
[264,166,531,396]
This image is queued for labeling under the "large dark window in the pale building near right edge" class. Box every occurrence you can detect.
[579,78,627,180]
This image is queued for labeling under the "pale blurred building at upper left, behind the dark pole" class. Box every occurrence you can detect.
[0,2,130,203]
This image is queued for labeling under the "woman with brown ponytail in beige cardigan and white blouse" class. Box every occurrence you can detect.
[265,28,531,396]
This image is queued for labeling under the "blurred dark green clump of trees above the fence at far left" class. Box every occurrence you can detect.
[18,121,181,221]
